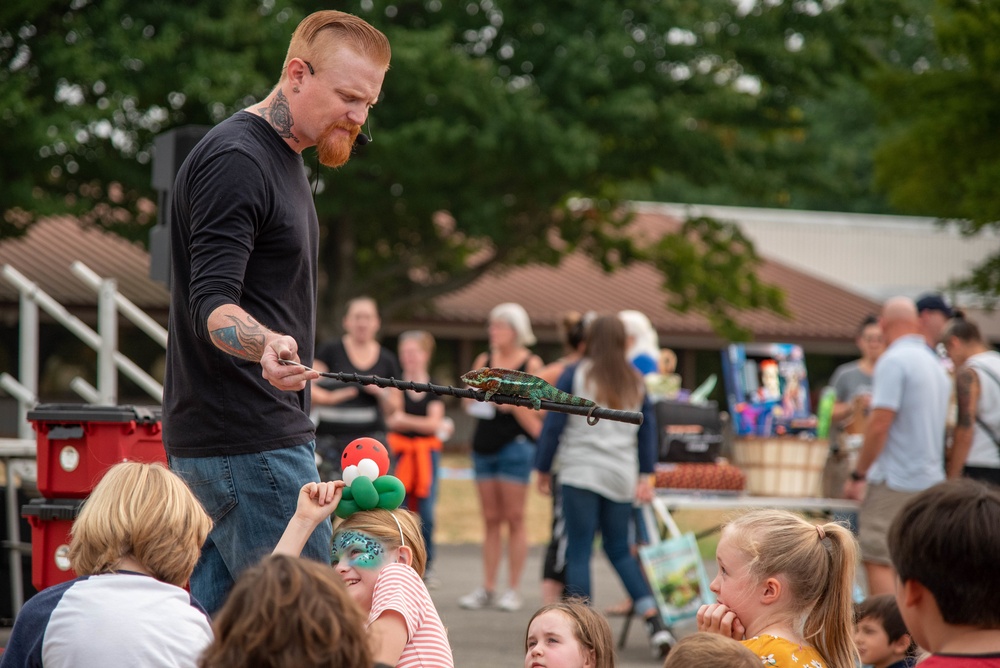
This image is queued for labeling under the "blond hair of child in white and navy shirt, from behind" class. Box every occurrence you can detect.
[69,462,212,587]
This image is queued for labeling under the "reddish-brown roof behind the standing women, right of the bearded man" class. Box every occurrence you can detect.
[396,212,880,353]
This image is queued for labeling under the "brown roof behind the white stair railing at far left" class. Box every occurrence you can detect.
[0,216,170,322]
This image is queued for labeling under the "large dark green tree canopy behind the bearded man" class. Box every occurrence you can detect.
[0,0,916,336]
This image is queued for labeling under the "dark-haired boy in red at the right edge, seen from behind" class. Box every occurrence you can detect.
[888,479,1000,668]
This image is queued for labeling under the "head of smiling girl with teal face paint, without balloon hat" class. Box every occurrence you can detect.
[331,508,427,610]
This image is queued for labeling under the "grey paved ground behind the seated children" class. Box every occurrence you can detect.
[431,545,694,668]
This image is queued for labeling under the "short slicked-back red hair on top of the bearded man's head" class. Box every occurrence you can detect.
[281,9,392,81]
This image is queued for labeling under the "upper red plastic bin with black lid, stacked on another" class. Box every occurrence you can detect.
[28,404,167,499]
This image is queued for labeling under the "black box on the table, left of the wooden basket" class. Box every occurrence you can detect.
[654,400,722,464]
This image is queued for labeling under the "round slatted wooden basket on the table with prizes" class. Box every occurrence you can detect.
[733,436,829,497]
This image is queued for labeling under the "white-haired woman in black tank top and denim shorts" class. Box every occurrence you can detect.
[458,302,542,612]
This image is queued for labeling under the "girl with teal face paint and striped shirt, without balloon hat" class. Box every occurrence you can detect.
[274,480,454,668]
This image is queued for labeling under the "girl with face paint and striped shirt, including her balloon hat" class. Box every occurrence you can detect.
[274,438,454,668]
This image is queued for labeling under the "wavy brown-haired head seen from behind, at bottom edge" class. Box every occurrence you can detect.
[199,555,373,668]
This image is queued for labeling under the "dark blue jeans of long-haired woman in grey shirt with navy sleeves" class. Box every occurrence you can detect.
[562,483,656,614]
